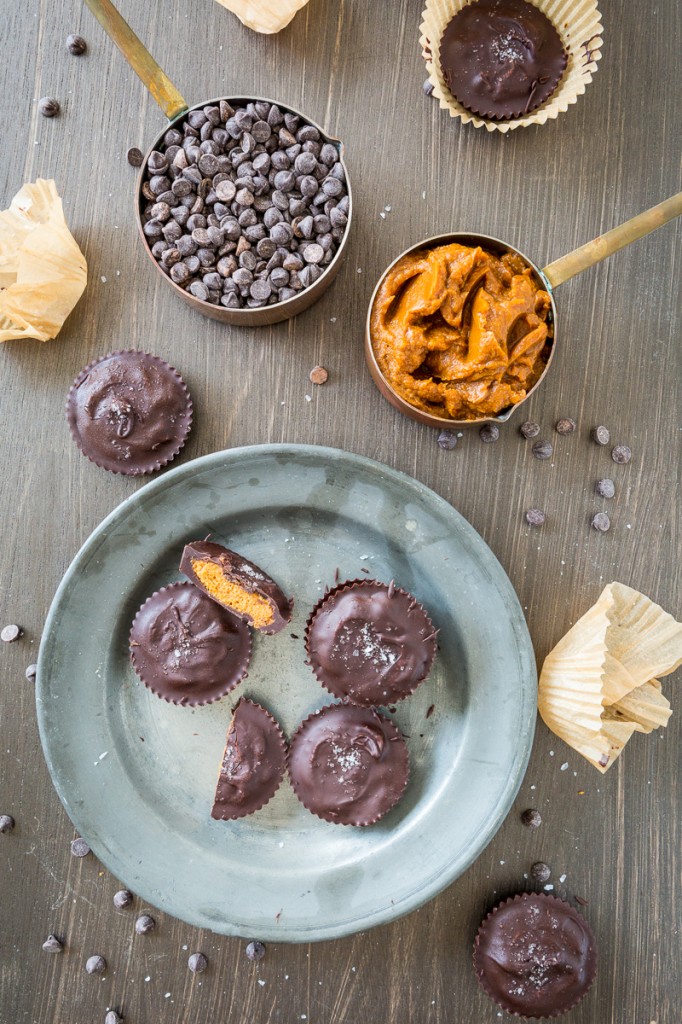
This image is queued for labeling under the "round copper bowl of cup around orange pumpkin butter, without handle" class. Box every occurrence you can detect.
[365,231,557,430]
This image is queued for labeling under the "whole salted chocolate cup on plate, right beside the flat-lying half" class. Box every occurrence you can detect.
[289,703,409,825]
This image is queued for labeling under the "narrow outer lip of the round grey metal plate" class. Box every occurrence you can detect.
[36,442,538,943]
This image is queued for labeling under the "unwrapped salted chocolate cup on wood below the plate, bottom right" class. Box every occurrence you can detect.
[474,893,597,1020]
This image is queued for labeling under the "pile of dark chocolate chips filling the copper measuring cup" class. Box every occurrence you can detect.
[141,99,349,309]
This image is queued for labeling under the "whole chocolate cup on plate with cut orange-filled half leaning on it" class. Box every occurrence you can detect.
[130,583,251,708]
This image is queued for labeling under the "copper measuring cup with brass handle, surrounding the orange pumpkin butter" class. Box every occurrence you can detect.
[365,193,682,430]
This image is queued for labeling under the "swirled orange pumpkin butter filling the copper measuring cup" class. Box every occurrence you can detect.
[370,244,551,420]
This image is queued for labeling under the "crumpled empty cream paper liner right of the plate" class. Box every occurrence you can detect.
[538,583,682,773]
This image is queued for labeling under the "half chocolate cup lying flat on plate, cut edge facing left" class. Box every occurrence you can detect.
[211,697,287,821]
